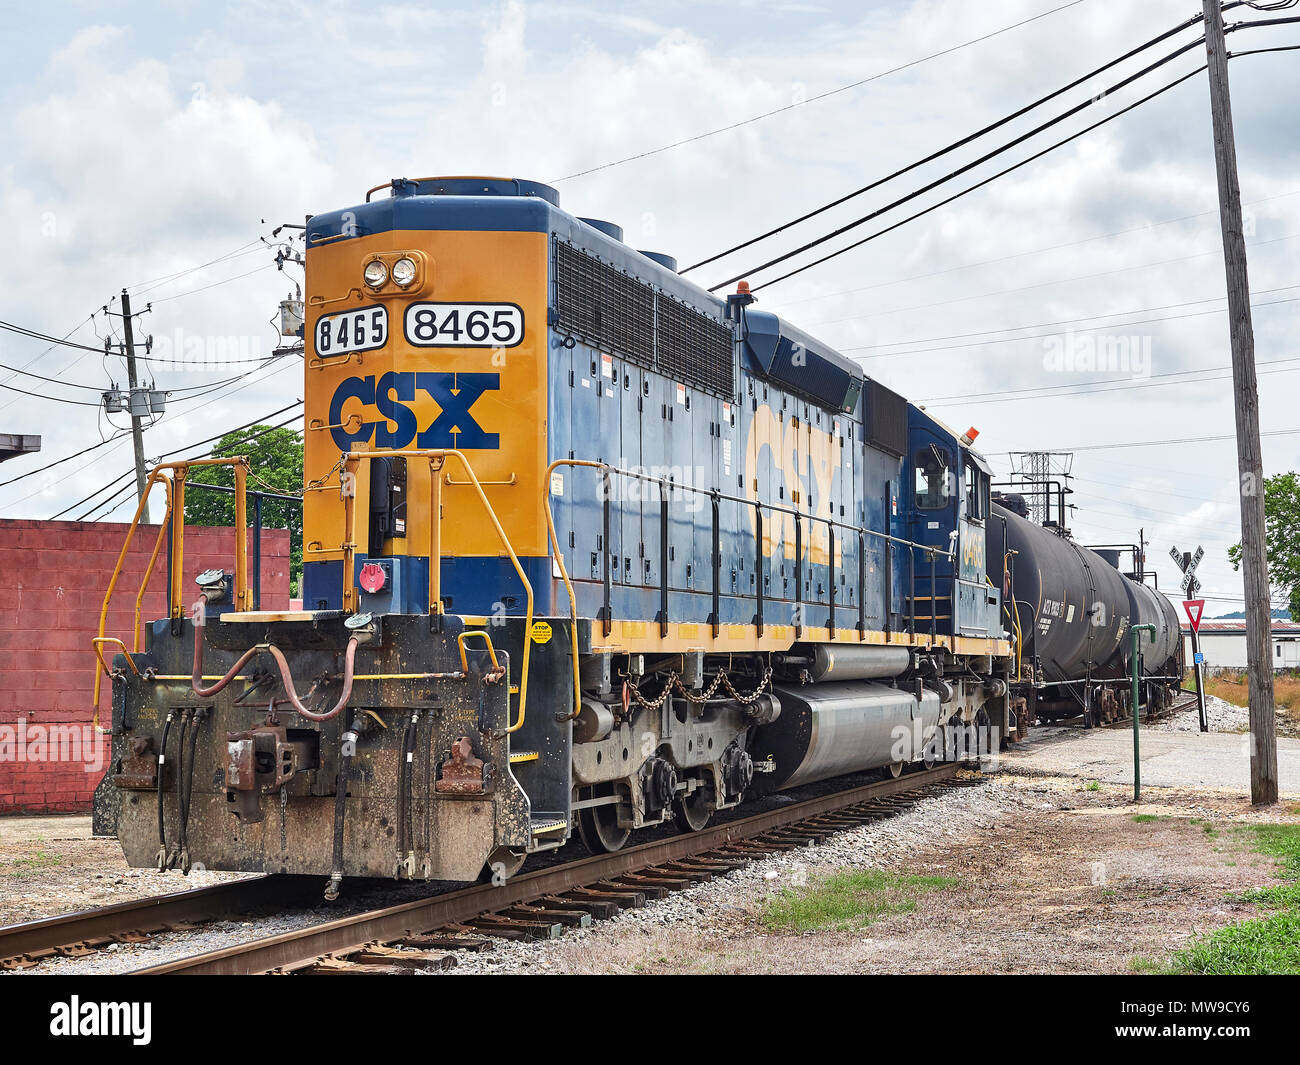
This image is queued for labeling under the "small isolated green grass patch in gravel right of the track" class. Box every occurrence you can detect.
[762,870,957,932]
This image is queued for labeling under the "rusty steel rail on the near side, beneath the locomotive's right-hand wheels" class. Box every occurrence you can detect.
[134,762,958,975]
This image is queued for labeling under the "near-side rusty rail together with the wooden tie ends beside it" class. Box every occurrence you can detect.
[135,765,984,975]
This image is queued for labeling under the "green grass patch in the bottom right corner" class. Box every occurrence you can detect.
[1164,824,1300,975]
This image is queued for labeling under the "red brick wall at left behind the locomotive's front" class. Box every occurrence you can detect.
[0,520,289,814]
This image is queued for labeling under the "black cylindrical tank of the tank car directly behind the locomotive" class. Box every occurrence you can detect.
[989,503,1131,683]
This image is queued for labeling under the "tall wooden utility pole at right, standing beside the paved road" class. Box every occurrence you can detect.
[1203,0,1278,805]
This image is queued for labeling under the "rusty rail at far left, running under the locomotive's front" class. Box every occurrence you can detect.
[0,875,320,970]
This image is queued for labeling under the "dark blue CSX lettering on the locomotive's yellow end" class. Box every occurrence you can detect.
[329,372,501,451]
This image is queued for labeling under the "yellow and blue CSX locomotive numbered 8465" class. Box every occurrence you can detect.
[96,178,1011,895]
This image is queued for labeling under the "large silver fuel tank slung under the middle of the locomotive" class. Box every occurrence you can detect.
[750,680,940,793]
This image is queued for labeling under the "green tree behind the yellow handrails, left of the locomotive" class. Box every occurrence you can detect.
[185,425,303,596]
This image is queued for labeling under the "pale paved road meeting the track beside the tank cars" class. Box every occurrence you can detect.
[1001,728,1300,797]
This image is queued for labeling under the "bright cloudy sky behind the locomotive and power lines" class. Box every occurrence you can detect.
[0,0,1300,614]
